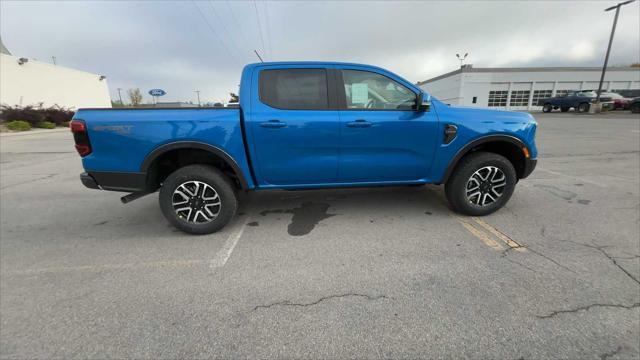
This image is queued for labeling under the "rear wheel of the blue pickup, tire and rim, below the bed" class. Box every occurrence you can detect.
[159,165,238,234]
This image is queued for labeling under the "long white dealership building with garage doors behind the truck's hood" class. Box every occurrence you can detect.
[417,65,640,110]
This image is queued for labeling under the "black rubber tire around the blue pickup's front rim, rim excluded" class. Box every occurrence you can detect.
[445,152,518,216]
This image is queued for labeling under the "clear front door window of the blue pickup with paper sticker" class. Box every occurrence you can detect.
[342,70,416,110]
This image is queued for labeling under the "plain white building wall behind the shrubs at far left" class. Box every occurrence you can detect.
[0,54,111,109]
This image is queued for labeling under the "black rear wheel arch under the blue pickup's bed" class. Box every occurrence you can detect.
[140,141,248,191]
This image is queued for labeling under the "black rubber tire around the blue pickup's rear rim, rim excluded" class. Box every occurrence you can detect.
[159,165,238,234]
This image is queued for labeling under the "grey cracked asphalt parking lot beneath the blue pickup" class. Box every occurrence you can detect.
[0,113,640,359]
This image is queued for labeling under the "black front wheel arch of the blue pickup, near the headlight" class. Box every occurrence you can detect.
[440,135,529,184]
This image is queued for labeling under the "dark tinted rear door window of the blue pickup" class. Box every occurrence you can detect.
[259,69,329,110]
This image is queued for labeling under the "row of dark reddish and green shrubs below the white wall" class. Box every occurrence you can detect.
[0,104,74,129]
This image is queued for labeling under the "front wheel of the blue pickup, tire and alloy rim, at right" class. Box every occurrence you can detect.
[445,152,518,216]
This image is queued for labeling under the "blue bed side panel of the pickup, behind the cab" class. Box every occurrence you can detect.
[75,108,255,190]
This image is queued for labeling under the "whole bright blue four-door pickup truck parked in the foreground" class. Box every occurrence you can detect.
[70,62,537,234]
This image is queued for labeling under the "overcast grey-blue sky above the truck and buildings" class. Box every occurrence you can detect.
[0,0,640,101]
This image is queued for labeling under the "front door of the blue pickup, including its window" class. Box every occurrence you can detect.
[336,67,438,183]
